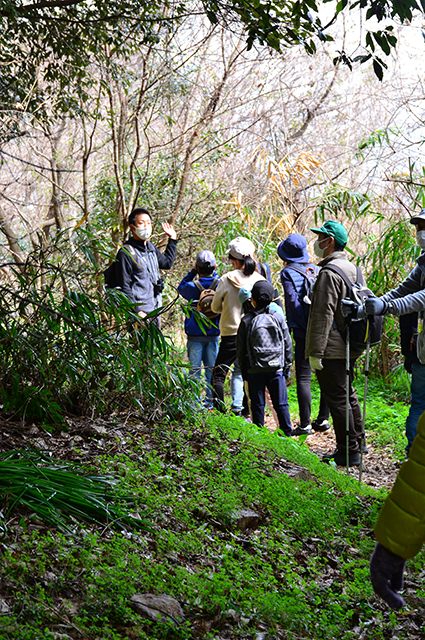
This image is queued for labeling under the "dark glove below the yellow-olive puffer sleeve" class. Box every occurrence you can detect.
[370,542,406,609]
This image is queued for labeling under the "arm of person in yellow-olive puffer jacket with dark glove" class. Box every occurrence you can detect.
[370,412,425,609]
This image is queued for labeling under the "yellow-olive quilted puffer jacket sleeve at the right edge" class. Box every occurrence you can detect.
[374,411,425,559]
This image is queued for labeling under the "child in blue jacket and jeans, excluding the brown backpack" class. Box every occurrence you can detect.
[177,250,220,409]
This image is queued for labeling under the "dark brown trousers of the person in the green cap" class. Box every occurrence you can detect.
[316,359,362,453]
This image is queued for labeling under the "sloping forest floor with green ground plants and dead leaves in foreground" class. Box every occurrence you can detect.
[0,414,425,640]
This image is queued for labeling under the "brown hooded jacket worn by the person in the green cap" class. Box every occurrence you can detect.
[306,251,361,360]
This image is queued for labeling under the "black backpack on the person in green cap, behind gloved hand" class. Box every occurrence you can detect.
[322,264,384,351]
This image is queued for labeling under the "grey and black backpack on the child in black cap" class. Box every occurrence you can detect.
[247,307,285,371]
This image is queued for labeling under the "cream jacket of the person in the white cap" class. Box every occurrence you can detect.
[211,269,265,336]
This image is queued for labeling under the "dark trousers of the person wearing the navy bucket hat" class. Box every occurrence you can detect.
[294,335,329,429]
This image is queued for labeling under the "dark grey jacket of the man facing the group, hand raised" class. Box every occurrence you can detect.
[117,238,177,313]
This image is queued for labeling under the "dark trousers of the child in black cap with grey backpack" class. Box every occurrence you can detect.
[246,369,292,436]
